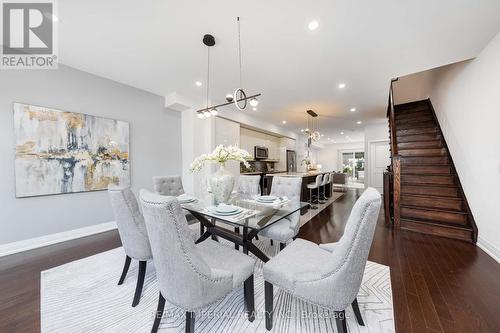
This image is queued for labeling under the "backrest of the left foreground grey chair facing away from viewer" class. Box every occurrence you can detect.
[140,190,232,311]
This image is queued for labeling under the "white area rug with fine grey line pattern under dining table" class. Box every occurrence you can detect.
[40,239,395,333]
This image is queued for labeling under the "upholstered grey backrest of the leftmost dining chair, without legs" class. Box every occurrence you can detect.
[108,185,151,260]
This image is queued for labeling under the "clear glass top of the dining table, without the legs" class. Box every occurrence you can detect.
[179,194,309,230]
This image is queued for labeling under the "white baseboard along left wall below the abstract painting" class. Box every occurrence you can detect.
[0,222,116,257]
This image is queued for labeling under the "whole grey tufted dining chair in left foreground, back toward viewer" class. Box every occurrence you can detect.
[140,190,255,332]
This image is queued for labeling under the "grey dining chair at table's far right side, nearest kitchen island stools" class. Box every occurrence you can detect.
[259,176,302,249]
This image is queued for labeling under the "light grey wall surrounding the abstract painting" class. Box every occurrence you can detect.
[0,65,181,244]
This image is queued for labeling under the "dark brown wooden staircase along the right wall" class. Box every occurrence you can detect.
[390,100,477,242]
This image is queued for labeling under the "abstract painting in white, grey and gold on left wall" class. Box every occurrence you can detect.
[14,103,130,198]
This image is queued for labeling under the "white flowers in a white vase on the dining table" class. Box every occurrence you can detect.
[189,145,252,203]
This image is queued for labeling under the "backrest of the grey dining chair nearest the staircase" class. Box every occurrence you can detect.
[296,188,381,309]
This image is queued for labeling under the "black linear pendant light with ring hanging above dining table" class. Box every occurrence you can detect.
[196,17,261,118]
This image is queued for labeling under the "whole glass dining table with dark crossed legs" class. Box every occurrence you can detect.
[181,195,309,262]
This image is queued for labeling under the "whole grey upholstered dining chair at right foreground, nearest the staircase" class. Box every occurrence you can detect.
[263,188,381,333]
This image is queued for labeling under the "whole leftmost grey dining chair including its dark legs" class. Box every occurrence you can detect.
[108,185,153,306]
